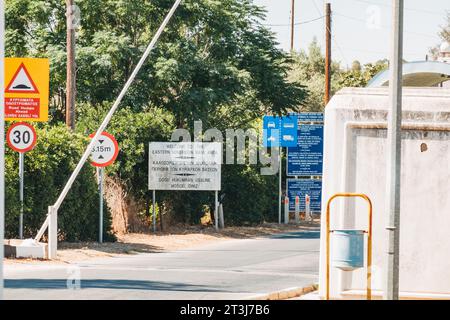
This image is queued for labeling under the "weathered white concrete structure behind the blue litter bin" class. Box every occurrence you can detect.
[319,88,450,299]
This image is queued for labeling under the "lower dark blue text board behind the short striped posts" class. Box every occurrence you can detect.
[286,179,322,212]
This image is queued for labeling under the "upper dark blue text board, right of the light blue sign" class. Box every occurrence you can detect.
[287,124,324,177]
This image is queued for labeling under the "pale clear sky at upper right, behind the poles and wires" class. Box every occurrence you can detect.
[254,0,450,67]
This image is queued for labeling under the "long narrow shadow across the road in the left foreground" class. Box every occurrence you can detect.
[5,279,227,292]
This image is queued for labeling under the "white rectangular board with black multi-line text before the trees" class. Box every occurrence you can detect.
[148,142,222,191]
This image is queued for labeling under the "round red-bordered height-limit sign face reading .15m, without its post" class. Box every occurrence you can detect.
[90,132,119,168]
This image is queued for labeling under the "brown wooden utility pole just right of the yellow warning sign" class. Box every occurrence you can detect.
[66,0,77,131]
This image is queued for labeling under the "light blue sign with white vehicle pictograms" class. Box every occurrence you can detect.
[263,116,298,148]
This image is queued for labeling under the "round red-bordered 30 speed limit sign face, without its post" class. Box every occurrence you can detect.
[6,122,37,153]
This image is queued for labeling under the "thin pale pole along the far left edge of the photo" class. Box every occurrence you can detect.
[0,1,5,300]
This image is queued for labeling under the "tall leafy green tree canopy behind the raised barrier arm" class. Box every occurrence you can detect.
[7,0,306,126]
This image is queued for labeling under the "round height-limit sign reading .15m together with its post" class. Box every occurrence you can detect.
[90,132,119,243]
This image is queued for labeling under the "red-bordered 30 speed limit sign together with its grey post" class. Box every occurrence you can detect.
[6,122,37,239]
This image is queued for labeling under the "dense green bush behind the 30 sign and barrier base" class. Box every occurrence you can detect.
[5,125,115,241]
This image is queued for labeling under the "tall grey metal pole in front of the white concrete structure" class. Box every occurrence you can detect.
[384,0,404,300]
